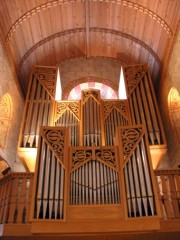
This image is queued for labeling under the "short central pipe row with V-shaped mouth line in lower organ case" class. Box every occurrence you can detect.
[70,160,120,205]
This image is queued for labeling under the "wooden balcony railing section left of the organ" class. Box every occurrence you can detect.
[0,173,34,224]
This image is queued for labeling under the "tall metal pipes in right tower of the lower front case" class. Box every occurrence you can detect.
[124,129,156,217]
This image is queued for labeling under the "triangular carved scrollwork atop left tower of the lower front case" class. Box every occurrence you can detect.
[41,127,65,162]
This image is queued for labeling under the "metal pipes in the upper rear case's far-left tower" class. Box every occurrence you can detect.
[23,76,53,147]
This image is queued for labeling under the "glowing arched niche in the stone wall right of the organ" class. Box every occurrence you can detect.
[168,87,180,142]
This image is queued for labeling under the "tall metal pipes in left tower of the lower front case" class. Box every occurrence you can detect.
[35,139,65,219]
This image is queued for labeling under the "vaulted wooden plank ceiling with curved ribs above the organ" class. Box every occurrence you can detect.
[0,0,180,94]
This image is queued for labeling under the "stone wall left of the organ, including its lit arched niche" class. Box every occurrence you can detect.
[0,38,24,171]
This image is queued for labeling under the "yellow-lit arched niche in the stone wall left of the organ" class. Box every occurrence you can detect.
[0,93,12,149]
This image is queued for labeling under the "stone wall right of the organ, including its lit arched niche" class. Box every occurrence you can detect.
[159,31,180,167]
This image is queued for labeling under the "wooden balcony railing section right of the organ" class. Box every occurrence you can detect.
[154,169,180,219]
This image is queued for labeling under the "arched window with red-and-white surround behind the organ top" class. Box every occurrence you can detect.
[63,76,118,100]
